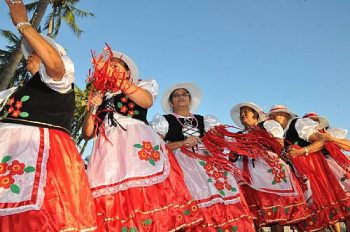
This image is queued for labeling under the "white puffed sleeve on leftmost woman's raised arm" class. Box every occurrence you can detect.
[39,56,75,93]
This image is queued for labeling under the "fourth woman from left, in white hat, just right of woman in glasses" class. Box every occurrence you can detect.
[230,102,310,231]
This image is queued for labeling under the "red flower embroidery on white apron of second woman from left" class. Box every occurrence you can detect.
[134,141,160,166]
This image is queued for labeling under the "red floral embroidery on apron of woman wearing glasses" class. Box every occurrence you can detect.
[199,160,237,196]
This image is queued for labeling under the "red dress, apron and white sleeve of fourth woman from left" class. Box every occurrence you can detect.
[234,120,310,227]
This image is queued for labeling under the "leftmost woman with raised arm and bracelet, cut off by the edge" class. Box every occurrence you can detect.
[0,0,97,231]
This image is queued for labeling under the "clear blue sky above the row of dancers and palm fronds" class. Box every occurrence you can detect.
[0,0,350,141]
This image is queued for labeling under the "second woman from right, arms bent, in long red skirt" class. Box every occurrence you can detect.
[269,105,350,231]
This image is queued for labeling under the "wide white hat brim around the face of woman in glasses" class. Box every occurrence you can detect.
[162,82,202,114]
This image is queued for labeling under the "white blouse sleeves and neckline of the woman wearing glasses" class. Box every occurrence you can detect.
[149,113,221,136]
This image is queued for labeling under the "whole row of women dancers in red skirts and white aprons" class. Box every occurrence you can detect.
[0,0,350,232]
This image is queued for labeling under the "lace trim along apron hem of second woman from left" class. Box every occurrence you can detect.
[92,154,170,198]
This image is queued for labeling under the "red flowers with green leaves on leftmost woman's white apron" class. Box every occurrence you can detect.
[0,155,35,194]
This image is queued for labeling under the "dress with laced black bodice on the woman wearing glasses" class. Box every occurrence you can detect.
[151,114,255,232]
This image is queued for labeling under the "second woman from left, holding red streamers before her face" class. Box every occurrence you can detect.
[83,53,202,231]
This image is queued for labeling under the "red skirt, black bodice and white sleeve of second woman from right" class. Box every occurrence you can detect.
[285,118,350,231]
